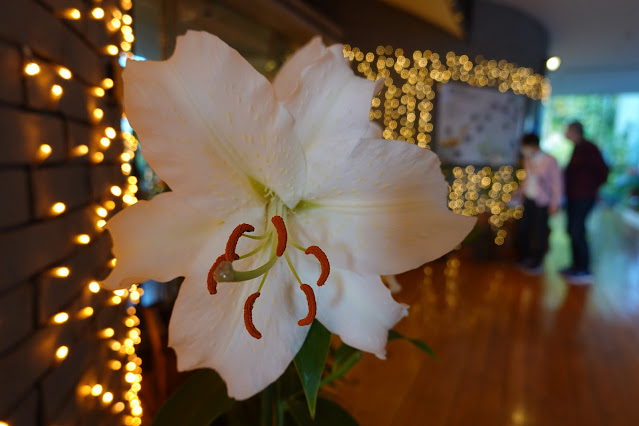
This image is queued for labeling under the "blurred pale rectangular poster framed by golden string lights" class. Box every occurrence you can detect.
[435,83,526,166]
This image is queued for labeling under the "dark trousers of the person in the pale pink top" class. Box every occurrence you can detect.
[517,198,549,266]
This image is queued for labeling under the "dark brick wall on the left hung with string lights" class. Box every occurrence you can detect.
[0,0,128,426]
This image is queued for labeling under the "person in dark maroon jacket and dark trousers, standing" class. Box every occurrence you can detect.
[562,121,608,283]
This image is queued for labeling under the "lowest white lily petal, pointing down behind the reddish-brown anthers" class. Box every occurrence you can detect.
[169,261,309,399]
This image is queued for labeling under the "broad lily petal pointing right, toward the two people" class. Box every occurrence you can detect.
[291,140,475,275]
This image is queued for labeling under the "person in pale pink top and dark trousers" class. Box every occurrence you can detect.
[517,133,563,274]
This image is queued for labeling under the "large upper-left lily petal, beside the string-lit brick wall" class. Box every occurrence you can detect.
[123,31,305,207]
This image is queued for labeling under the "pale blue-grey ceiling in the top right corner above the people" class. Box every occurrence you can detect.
[488,0,639,93]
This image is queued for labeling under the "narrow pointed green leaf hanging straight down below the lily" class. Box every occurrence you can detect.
[294,320,331,418]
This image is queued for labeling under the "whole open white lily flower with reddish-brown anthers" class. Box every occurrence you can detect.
[103,32,474,399]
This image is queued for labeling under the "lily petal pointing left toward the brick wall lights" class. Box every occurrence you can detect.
[101,192,264,289]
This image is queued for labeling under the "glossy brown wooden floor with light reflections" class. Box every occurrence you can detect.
[334,206,639,426]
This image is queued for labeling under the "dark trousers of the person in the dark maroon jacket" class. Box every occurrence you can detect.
[566,198,595,272]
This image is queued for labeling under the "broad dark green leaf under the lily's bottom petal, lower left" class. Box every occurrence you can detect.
[153,368,235,426]
